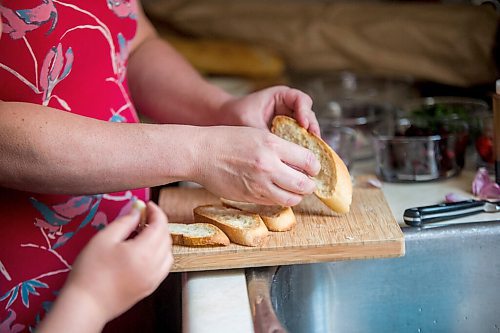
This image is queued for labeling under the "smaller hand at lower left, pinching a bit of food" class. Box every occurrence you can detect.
[64,202,173,320]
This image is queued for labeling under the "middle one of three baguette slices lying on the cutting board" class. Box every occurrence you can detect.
[193,205,269,246]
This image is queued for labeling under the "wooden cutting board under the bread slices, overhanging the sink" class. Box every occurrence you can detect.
[159,181,405,272]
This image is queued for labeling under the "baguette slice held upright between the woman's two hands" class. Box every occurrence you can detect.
[271,116,352,213]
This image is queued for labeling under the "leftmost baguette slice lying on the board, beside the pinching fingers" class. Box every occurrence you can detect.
[168,223,230,246]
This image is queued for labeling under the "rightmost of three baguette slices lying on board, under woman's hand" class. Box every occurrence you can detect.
[220,198,297,231]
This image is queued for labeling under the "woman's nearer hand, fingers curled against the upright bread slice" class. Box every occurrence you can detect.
[194,126,321,206]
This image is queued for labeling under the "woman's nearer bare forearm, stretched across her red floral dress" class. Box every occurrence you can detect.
[0,102,199,194]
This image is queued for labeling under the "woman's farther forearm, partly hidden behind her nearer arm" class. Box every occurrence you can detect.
[127,36,233,125]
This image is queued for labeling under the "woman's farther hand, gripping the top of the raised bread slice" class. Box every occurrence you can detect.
[221,86,320,136]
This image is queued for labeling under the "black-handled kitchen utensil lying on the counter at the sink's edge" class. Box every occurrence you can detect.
[403,199,500,227]
